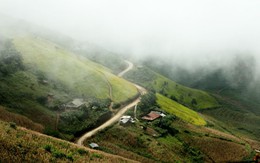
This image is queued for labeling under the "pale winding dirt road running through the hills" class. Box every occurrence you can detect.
[76,61,147,145]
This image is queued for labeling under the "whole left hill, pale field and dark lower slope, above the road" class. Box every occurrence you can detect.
[0,36,138,139]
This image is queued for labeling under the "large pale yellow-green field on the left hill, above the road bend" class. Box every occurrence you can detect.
[13,37,137,102]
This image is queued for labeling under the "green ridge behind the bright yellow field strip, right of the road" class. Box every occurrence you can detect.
[125,67,219,109]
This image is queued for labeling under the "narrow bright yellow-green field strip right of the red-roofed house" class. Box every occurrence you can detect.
[156,93,206,125]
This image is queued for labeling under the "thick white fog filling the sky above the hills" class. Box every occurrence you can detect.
[0,0,260,79]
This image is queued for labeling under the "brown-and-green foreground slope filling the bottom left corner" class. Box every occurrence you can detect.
[0,121,134,162]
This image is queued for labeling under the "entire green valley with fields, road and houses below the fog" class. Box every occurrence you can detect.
[0,17,260,163]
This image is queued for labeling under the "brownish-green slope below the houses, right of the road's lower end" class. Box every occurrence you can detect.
[85,120,254,162]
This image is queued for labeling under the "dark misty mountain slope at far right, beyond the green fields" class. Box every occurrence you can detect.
[141,55,260,139]
